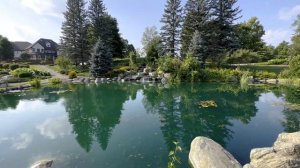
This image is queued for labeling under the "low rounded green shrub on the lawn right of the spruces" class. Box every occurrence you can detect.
[226,49,260,64]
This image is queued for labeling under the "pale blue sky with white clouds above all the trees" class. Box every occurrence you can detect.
[0,0,300,48]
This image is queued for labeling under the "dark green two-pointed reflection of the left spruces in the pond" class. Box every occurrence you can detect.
[65,84,141,152]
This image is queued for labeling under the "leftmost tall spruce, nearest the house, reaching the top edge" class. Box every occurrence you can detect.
[61,0,90,65]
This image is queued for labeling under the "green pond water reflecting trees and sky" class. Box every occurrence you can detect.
[0,83,300,168]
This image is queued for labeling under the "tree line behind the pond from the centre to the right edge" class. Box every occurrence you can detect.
[142,0,300,68]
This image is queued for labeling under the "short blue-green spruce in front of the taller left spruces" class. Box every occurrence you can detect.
[90,40,112,77]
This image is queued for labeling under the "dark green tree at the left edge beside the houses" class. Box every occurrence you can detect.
[0,35,14,60]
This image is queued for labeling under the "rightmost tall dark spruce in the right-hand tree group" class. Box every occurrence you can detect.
[208,0,241,66]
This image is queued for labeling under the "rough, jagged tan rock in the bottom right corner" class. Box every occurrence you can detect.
[244,132,300,168]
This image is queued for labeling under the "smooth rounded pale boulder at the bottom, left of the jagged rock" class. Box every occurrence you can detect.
[189,137,242,168]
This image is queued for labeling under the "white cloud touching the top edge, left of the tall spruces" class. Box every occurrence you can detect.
[21,0,62,17]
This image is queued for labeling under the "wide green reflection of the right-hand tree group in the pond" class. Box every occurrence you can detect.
[143,84,258,149]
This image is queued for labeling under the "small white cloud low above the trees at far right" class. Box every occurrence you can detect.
[263,29,291,46]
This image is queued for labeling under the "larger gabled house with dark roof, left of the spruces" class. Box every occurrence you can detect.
[25,38,58,61]
